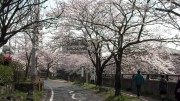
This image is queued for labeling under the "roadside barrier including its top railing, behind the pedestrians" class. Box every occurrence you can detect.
[68,74,179,101]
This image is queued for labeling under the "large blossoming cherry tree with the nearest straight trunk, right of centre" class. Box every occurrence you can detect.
[60,0,179,95]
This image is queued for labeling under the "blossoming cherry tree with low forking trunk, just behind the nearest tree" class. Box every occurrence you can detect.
[52,0,112,85]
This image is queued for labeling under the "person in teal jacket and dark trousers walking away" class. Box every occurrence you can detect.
[135,70,144,98]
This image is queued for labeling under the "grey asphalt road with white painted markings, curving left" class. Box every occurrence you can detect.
[44,80,104,101]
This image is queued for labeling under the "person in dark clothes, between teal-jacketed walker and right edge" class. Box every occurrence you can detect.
[159,75,167,101]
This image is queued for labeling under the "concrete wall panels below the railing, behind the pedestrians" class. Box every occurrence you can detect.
[69,75,176,101]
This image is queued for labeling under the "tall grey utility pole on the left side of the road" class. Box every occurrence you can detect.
[31,0,40,81]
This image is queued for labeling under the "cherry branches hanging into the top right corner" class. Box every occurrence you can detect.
[155,0,180,47]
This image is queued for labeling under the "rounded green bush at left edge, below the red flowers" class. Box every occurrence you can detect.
[0,65,14,85]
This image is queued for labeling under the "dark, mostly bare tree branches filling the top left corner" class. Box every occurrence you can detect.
[0,0,52,47]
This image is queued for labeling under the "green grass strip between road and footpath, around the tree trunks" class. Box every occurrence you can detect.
[71,82,143,101]
